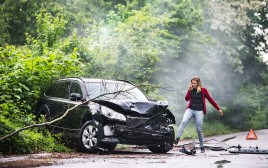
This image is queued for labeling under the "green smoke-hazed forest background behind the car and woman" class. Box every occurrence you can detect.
[0,0,268,154]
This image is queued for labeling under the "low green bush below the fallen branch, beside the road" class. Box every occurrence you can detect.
[0,116,70,154]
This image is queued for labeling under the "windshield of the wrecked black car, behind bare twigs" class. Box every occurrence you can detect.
[86,82,148,101]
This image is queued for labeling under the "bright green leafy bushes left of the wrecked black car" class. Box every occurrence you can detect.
[0,10,82,154]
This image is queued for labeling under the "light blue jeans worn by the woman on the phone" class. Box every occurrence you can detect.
[177,108,204,147]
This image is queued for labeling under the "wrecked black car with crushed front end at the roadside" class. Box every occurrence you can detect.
[36,77,175,153]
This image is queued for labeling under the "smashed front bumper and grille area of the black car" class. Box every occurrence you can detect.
[99,113,174,145]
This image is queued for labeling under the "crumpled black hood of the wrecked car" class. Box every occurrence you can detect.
[95,99,168,116]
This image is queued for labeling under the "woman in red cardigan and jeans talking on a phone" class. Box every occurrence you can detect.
[175,76,223,153]
